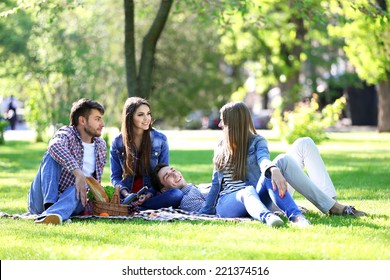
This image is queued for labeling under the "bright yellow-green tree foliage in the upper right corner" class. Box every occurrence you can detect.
[210,0,390,131]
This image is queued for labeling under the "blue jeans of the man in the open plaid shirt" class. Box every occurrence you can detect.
[28,152,84,221]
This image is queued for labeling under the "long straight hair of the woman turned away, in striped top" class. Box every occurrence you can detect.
[214,102,257,180]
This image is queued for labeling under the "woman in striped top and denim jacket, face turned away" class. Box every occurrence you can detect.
[201,102,310,227]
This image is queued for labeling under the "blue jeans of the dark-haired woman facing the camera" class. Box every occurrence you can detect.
[139,189,184,210]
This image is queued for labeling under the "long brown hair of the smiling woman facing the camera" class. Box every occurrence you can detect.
[121,97,153,179]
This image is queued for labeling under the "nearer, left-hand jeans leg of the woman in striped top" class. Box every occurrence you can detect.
[216,186,271,223]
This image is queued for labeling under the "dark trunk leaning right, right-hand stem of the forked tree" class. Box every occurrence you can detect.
[138,0,173,99]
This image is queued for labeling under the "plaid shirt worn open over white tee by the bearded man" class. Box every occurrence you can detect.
[48,126,106,193]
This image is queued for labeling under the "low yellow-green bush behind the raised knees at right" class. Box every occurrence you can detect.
[271,97,346,144]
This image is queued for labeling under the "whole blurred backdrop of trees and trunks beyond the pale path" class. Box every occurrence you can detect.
[0,0,390,141]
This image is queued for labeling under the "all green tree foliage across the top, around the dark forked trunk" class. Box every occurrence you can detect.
[0,0,390,133]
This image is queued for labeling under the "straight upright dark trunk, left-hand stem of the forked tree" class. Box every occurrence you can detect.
[124,0,138,97]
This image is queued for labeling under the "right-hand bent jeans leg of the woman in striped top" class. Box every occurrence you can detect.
[256,176,302,221]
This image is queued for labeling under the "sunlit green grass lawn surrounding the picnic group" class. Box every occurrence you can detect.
[0,132,390,260]
